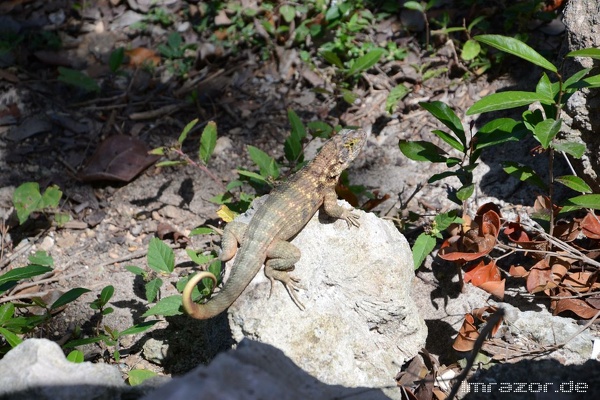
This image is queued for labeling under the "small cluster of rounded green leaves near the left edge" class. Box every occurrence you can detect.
[13,182,70,225]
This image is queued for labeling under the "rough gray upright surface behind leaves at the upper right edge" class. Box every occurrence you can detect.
[564,0,600,193]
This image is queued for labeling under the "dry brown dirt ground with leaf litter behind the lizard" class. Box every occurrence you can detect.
[0,1,596,390]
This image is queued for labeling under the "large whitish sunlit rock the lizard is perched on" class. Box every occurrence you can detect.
[225,195,427,396]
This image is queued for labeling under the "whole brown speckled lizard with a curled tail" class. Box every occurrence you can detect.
[183,129,367,319]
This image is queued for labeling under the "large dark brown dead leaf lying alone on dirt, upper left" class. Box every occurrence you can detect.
[78,135,160,182]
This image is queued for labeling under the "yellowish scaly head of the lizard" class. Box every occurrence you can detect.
[322,129,367,178]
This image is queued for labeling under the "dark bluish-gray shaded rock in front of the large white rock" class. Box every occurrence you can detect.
[143,339,388,400]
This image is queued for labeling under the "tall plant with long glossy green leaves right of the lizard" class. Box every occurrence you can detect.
[399,35,600,272]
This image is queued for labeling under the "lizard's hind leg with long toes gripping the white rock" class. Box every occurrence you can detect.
[265,239,304,310]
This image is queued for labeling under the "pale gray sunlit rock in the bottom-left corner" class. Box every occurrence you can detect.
[0,339,126,400]
